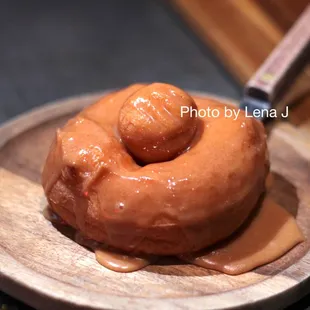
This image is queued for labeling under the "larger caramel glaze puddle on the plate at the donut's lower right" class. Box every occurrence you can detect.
[180,197,304,275]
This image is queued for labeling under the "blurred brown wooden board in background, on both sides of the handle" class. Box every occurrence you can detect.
[170,0,310,125]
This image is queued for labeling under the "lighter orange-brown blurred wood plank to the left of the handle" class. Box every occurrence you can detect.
[172,0,283,83]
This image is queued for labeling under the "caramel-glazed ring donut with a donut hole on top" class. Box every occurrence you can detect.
[42,83,269,255]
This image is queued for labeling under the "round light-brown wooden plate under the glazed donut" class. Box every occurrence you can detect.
[0,93,310,310]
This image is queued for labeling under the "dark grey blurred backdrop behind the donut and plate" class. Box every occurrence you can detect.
[0,0,307,310]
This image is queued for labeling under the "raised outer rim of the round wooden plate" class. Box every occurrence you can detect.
[0,89,310,309]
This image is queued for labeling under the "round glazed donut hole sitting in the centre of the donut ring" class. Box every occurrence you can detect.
[118,83,198,163]
